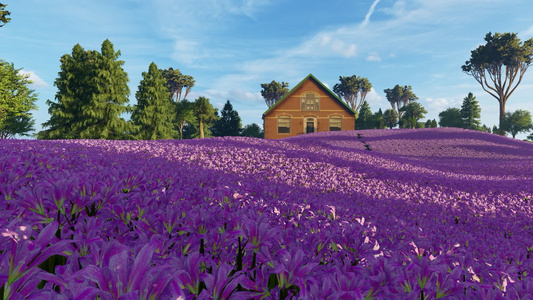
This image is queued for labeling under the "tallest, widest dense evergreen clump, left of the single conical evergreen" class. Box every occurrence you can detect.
[38,40,132,139]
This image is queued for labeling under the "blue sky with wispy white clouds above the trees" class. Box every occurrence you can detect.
[0,0,533,138]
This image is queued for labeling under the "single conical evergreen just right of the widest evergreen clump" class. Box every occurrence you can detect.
[131,62,177,140]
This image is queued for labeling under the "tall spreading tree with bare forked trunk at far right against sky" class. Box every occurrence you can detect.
[461,32,533,128]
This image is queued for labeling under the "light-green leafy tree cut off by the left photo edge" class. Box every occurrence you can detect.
[0,60,37,139]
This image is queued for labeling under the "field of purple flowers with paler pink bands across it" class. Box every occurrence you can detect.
[0,128,533,300]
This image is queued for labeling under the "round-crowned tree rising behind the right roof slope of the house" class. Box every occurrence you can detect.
[333,75,372,112]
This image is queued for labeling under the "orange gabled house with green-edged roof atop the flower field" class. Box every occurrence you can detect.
[263,74,355,139]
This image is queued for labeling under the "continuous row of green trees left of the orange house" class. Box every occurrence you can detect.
[37,40,262,140]
